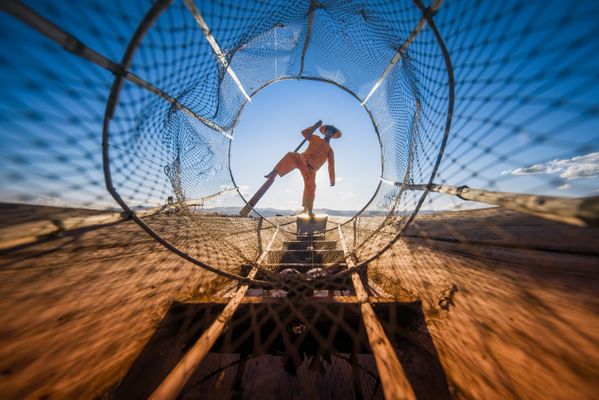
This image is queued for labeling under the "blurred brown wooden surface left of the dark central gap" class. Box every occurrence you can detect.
[0,205,232,399]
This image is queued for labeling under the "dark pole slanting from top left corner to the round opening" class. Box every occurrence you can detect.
[0,0,232,139]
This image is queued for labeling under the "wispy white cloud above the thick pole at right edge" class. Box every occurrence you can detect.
[501,152,599,181]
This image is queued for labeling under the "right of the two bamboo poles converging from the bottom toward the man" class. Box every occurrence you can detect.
[339,226,416,400]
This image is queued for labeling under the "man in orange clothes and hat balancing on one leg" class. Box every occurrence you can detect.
[264,121,341,218]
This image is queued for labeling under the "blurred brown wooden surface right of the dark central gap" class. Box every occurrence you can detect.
[376,209,599,399]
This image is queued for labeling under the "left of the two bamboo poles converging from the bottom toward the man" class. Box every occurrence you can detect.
[150,227,279,400]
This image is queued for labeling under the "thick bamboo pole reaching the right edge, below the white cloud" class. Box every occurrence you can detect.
[392,180,599,226]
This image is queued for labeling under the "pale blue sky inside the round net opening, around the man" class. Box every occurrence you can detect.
[231,80,381,210]
